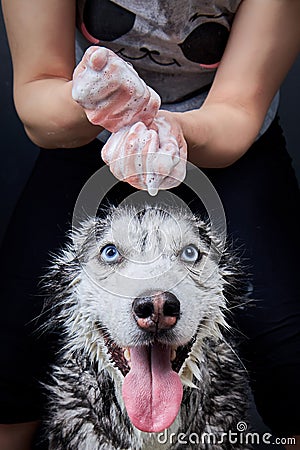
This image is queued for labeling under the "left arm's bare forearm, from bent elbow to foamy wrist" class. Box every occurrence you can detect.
[15,78,101,148]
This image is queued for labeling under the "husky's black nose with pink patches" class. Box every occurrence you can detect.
[132,292,180,333]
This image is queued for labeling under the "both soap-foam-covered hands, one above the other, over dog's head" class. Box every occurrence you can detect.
[72,46,186,195]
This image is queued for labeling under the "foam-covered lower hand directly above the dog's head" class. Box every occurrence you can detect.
[102,111,187,195]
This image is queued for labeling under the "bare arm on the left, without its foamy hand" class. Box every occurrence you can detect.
[2,0,99,148]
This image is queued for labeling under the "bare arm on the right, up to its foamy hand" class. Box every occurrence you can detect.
[176,0,300,167]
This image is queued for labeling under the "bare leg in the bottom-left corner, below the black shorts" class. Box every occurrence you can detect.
[0,422,38,450]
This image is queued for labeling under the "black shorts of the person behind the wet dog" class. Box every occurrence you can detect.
[0,120,300,434]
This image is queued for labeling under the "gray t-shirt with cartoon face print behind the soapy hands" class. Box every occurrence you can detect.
[77,0,279,135]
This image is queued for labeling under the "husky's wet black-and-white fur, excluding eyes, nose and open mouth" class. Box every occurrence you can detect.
[47,207,250,450]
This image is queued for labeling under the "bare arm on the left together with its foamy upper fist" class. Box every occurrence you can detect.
[2,0,160,148]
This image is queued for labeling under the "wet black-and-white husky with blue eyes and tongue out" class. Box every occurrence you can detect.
[48,206,249,450]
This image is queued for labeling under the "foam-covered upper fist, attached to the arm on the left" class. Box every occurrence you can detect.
[72,46,160,132]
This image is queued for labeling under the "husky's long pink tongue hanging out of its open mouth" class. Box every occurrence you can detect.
[122,344,183,433]
